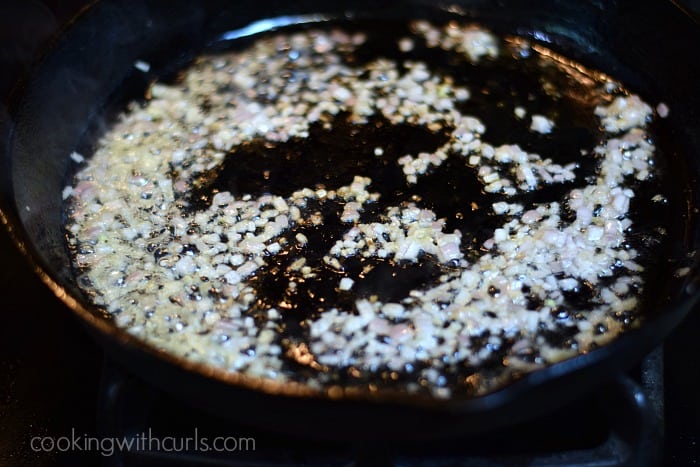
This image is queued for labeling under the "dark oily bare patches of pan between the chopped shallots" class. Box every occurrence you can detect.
[78,22,677,393]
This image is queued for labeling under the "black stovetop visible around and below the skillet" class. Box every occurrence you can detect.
[0,0,700,466]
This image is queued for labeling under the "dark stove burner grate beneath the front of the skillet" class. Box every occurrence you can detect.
[98,348,664,467]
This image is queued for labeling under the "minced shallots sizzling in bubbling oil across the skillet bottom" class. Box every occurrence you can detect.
[65,21,671,397]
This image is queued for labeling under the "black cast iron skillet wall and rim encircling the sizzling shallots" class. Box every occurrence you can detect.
[1,0,700,439]
